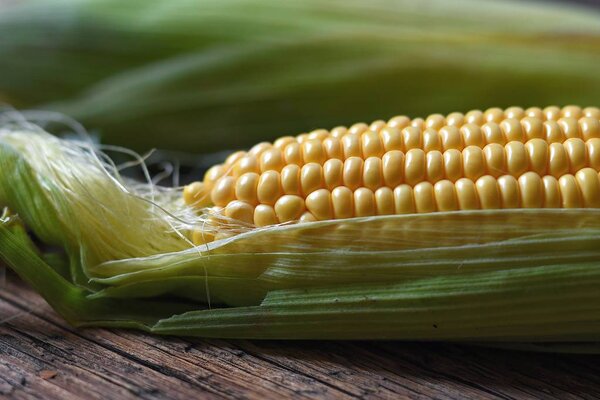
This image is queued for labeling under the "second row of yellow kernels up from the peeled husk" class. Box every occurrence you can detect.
[211,139,600,206]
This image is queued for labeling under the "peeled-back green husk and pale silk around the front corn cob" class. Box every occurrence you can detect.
[0,126,600,346]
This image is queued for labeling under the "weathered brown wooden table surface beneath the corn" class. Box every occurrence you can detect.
[0,274,600,399]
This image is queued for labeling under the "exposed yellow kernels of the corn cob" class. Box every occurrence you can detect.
[184,106,600,243]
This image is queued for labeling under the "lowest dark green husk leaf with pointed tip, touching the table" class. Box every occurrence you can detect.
[153,263,600,342]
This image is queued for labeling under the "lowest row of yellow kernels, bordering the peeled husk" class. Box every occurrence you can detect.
[213,168,600,231]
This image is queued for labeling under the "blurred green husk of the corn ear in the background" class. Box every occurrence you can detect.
[0,0,600,152]
